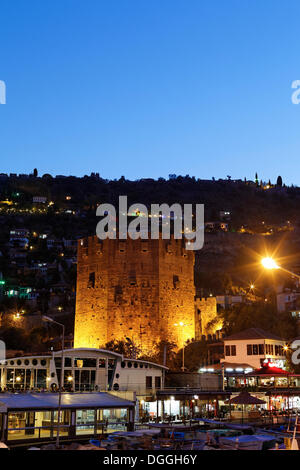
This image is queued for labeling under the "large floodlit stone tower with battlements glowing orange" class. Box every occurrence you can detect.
[74,236,195,352]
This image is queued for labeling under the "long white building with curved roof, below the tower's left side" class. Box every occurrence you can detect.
[1,348,167,399]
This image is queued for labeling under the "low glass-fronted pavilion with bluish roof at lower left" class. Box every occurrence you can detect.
[0,392,135,446]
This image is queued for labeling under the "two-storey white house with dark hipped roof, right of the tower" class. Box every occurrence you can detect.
[221,328,286,369]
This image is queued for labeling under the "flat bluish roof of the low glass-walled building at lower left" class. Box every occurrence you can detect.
[0,392,135,412]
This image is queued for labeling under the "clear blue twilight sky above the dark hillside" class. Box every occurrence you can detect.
[0,0,300,185]
